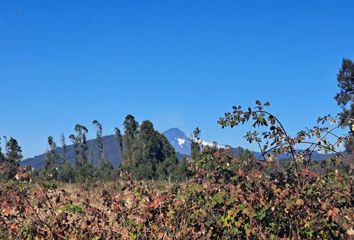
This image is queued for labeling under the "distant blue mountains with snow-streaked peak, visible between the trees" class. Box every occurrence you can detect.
[21,128,333,169]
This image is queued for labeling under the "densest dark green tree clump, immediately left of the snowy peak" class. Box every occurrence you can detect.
[118,115,178,181]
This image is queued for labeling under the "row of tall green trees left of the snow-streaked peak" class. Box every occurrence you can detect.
[0,114,191,183]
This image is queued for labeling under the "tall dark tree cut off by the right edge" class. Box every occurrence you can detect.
[335,59,354,152]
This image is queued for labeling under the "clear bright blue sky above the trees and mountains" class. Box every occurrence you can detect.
[0,0,354,157]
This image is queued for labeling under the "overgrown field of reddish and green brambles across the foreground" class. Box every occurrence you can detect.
[0,148,354,239]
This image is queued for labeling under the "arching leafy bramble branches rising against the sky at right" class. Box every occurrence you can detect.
[218,100,347,185]
